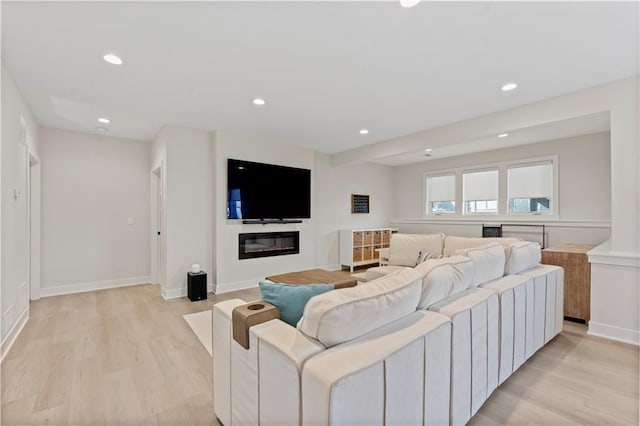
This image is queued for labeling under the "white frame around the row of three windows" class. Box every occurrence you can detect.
[422,155,560,221]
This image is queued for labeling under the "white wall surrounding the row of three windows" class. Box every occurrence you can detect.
[393,132,611,246]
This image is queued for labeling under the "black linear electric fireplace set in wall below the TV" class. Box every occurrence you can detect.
[238,231,300,259]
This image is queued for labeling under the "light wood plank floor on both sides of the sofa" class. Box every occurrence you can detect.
[1,285,639,425]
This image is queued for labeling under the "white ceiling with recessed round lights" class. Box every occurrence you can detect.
[2,1,639,159]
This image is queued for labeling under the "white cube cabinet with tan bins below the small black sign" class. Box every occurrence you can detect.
[340,228,397,272]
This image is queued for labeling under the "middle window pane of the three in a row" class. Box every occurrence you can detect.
[462,170,498,214]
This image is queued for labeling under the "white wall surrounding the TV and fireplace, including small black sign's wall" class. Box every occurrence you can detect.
[149,127,392,298]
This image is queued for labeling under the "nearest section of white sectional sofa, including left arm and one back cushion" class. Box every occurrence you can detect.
[213,268,451,425]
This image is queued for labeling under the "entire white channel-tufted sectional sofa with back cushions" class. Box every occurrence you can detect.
[213,235,564,426]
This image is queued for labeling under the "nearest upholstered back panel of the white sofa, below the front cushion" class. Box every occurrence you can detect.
[301,311,451,425]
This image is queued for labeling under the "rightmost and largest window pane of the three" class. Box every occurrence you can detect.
[507,161,553,213]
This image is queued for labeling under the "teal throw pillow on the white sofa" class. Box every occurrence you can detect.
[259,281,333,327]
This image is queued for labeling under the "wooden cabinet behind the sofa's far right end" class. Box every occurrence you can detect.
[542,244,595,324]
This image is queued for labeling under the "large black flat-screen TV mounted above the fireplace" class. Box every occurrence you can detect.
[227,158,311,219]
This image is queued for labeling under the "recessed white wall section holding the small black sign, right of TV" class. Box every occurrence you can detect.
[313,152,394,269]
